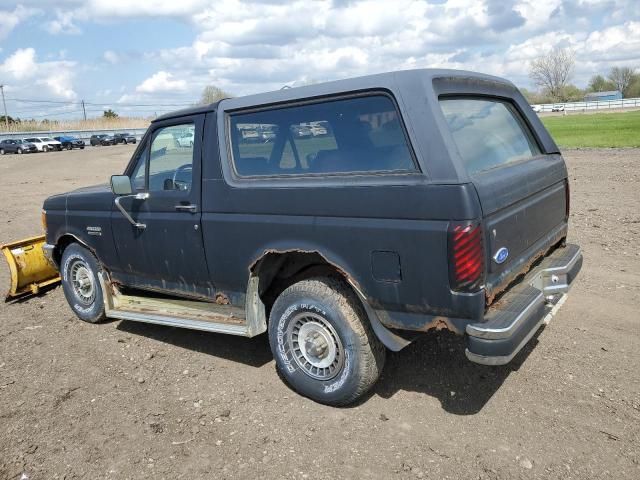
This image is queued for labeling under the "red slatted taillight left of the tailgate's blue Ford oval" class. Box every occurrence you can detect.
[449,222,484,292]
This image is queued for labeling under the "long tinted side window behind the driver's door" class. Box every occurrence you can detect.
[229,94,416,176]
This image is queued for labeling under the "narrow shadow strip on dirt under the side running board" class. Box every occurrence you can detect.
[116,320,273,367]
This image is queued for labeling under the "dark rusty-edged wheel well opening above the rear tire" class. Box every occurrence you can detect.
[251,251,352,319]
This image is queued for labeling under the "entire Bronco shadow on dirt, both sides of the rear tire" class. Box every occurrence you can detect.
[117,320,544,415]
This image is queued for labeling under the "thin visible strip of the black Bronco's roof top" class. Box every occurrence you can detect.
[152,68,515,123]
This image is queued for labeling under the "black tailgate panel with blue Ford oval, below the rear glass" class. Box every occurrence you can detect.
[473,155,567,303]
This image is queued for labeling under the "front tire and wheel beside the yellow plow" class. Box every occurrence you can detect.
[60,243,106,323]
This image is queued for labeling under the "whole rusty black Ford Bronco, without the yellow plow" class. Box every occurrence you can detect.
[44,70,582,405]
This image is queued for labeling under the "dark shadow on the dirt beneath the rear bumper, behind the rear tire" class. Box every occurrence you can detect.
[363,328,544,415]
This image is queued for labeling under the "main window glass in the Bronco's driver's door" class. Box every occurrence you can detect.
[148,123,195,192]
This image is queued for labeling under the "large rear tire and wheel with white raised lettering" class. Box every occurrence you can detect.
[269,277,386,406]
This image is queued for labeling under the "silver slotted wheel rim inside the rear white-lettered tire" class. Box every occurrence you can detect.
[287,312,344,380]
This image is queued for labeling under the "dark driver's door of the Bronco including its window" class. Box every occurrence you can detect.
[111,115,212,297]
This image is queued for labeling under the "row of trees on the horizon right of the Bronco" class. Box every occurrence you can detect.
[520,48,640,104]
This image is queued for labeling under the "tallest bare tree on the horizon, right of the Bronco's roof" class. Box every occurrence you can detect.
[529,48,576,100]
